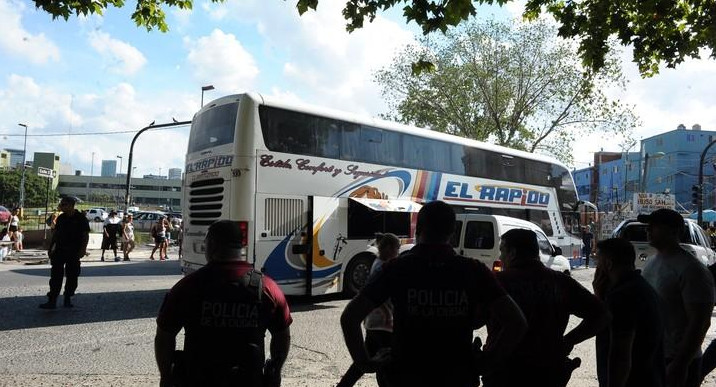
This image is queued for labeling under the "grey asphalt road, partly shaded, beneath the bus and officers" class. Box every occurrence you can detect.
[0,251,716,387]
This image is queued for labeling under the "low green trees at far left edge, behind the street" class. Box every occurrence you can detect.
[0,168,59,207]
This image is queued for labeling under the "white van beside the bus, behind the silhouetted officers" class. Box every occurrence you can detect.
[451,214,571,274]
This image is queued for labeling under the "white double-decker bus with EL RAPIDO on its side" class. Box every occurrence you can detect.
[182,94,580,295]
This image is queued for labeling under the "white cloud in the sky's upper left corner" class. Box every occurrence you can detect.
[0,0,60,64]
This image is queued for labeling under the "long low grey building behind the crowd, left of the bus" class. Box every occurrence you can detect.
[57,175,182,208]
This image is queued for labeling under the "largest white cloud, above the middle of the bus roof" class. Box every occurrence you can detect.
[199,0,414,115]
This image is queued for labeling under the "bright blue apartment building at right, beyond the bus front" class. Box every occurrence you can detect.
[572,125,716,212]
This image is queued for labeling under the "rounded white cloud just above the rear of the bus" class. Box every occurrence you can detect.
[185,29,259,93]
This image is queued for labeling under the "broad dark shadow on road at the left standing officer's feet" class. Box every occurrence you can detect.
[0,289,167,331]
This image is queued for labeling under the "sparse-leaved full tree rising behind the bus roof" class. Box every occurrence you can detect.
[376,21,637,162]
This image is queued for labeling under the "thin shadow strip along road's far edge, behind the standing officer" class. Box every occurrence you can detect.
[10,261,181,279]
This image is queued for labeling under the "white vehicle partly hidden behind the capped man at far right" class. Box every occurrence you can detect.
[612,219,716,269]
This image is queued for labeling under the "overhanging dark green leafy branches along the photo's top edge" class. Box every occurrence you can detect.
[29,0,716,76]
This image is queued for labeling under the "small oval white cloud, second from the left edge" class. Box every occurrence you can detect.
[89,32,147,75]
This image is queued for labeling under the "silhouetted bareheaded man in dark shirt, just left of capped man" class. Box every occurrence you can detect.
[594,238,666,387]
